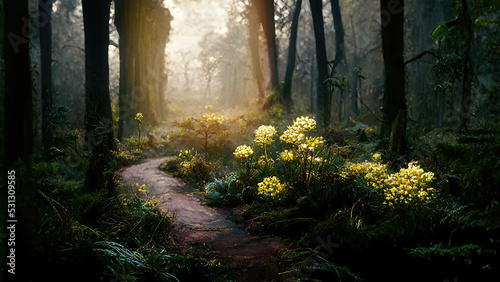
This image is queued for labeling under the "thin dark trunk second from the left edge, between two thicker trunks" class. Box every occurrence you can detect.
[38,0,53,150]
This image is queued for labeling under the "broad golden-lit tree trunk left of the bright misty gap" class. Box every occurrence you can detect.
[115,0,172,139]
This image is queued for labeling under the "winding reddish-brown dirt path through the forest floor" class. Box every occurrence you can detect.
[117,158,284,281]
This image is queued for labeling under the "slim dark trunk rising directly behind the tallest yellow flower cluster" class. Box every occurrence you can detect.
[309,0,330,132]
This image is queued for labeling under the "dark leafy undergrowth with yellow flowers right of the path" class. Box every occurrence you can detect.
[165,107,500,281]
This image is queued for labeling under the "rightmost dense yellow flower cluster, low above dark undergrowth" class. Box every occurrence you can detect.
[384,162,436,206]
